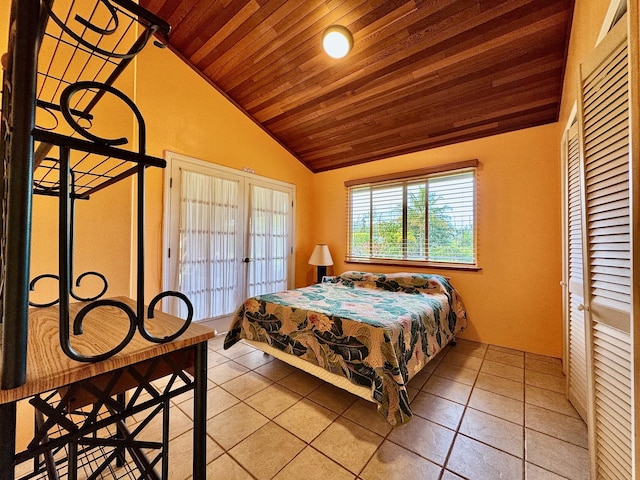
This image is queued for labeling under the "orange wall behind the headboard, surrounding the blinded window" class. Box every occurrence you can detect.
[314,124,562,357]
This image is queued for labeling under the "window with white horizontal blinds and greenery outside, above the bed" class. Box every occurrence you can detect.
[346,160,478,266]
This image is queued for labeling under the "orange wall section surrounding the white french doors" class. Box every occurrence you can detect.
[136,47,314,295]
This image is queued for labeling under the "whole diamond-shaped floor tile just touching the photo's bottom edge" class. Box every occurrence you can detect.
[229,422,305,480]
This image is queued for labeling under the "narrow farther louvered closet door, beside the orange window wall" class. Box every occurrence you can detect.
[566,123,588,421]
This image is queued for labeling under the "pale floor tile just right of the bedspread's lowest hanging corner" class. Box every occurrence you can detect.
[387,416,454,465]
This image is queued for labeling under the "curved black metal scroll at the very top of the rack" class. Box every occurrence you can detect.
[41,0,159,59]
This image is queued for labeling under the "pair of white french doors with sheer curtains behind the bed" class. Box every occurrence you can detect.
[163,152,294,329]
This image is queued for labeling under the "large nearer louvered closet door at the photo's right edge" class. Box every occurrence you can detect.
[582,18,635,480]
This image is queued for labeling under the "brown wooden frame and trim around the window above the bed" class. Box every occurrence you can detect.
[344,159,480,271]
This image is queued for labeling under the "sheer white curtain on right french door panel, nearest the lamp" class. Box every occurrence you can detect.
[248,185,290,297]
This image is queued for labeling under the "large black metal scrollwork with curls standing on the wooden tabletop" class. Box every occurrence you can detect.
[30,79,194,362]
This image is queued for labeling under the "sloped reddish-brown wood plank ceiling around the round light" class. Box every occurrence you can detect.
[140,0,574,172]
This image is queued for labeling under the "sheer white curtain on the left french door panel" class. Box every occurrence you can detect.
[178,170,241,320]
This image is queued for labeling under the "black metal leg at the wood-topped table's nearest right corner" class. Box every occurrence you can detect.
[193,342,207,480]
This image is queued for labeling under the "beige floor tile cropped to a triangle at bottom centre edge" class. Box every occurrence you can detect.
[274,447,355,480]
